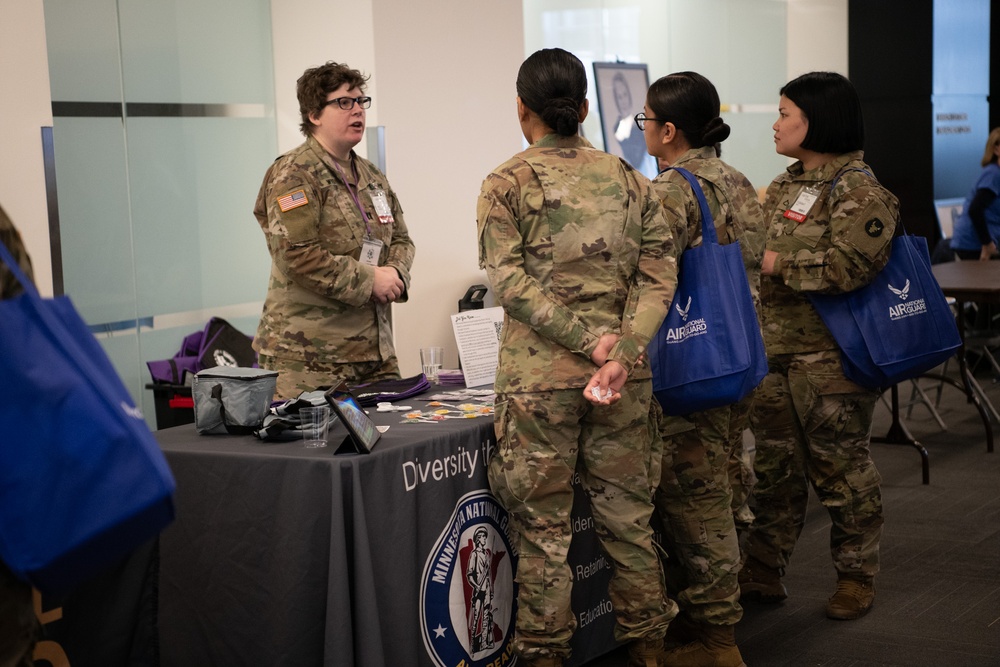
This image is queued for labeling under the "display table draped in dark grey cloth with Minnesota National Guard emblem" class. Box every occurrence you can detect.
[156,398,615,667]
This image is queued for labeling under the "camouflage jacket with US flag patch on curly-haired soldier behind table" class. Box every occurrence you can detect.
[254,137,414,363]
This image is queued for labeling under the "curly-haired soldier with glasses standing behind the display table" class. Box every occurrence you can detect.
[254,62,414,399]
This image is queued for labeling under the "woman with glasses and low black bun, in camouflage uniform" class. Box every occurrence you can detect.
[636,72,764,667]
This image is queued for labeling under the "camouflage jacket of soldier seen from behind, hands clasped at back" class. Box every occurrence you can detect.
[477,134,677,392]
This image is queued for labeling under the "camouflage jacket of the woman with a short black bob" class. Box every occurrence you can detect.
[760,151,899,355]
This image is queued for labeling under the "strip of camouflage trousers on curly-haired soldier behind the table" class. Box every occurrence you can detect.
[258,354,399,401]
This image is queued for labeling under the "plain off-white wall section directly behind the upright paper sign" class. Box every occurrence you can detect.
[372,0,524,376]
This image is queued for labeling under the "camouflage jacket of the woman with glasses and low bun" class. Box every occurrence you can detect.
[653,146,765,313]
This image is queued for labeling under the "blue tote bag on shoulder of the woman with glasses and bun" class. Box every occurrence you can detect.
[648,167,767,415]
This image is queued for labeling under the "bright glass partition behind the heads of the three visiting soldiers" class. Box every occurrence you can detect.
[523,0,788,188]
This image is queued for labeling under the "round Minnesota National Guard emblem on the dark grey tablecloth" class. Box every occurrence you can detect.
[420,491,517,667]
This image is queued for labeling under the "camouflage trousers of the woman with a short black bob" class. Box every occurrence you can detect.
[745,350,883,578]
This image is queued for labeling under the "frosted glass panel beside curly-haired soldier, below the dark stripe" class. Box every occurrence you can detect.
[126,118,276,316]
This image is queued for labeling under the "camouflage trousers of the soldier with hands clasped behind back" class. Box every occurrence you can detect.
[489,380,677,660]
